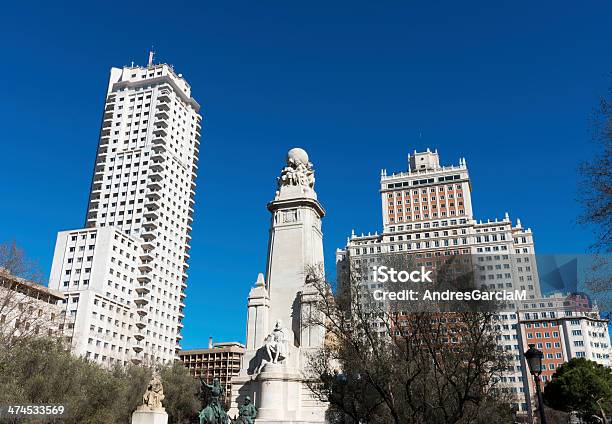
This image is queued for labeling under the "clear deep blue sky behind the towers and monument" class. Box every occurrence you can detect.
[0,1,612,348]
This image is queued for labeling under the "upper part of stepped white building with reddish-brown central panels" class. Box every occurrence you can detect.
[336,149,540,307]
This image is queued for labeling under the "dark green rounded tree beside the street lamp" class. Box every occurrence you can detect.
[544,358,612,422]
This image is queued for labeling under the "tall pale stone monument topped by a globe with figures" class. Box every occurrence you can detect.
[230,148,327,424]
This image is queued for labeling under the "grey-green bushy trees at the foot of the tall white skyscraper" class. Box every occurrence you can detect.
[0,338,199,424]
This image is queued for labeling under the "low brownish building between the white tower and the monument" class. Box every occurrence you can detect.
[179,338,245,399]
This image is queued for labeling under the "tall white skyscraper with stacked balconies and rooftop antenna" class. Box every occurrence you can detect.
[49,55,202,364]
